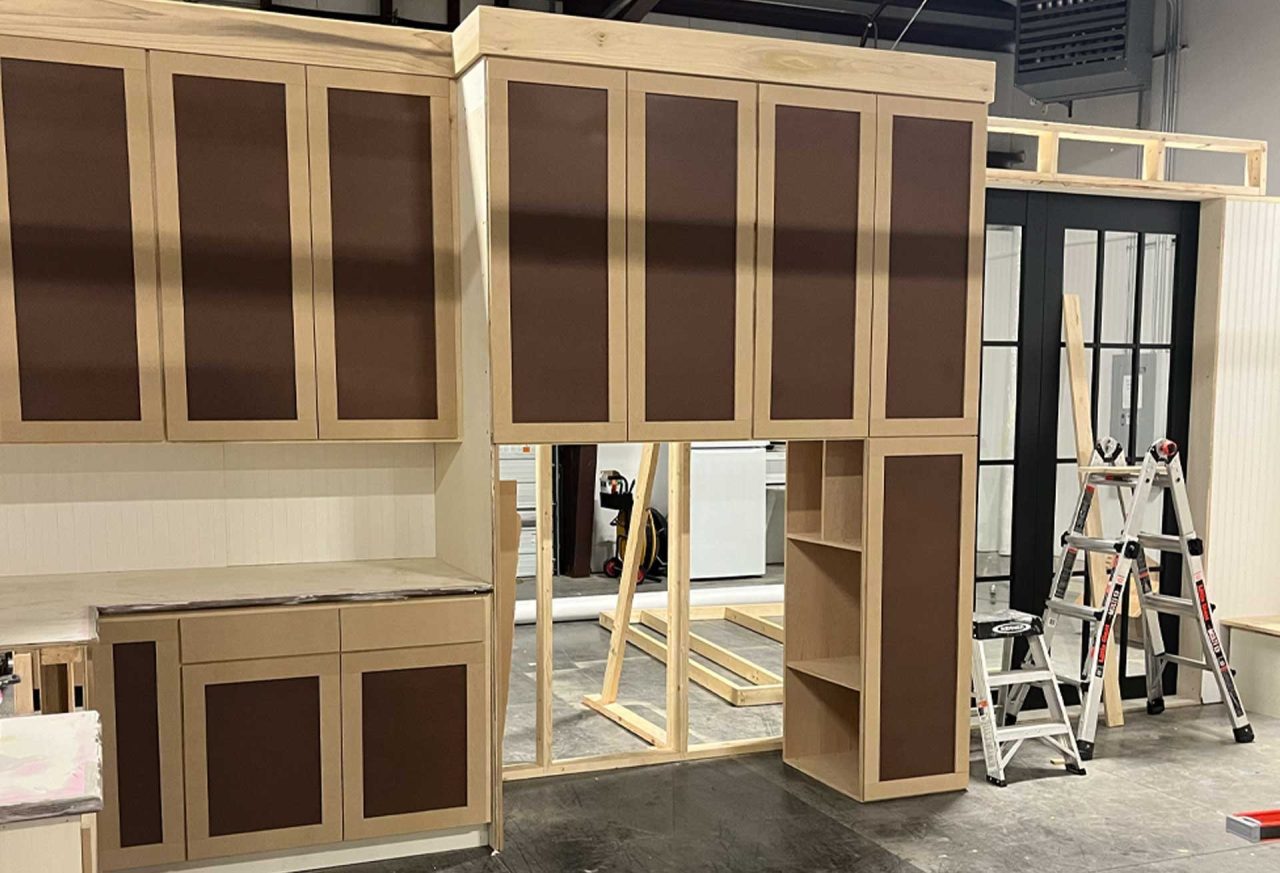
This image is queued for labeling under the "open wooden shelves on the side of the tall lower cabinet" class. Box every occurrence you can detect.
[782,440,867,800]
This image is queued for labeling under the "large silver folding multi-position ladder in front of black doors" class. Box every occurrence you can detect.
[1005,438,1253,760]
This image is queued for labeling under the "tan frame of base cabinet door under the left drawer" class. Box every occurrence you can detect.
[182,654,342,860]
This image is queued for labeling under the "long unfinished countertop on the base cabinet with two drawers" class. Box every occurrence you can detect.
[0,558,492,649]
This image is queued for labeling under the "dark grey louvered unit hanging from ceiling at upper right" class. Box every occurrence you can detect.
[1014,0,1155,102]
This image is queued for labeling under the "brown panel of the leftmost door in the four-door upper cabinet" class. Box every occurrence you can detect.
[497,82,609,422]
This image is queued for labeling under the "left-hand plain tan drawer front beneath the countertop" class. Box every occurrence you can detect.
[180,607,338,664]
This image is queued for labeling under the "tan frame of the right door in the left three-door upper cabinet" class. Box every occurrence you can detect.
[306,67,461,439]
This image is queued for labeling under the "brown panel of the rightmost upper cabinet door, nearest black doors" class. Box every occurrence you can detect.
[884,115,973,419]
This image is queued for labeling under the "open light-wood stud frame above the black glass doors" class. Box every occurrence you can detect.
[987,118,1267,200]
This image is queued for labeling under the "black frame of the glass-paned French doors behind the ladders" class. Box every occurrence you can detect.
[987,191,1199,703]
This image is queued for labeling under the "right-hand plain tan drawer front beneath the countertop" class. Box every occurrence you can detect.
[342,597,488,652]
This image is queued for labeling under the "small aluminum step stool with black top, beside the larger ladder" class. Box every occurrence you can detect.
[972,609,1084,787]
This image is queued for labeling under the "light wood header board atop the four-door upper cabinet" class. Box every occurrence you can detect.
[455,0,996,104]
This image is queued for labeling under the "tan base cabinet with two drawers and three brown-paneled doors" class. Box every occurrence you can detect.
[90,595,492,870]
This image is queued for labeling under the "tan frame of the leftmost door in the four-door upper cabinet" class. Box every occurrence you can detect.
[485,58,627,444]
